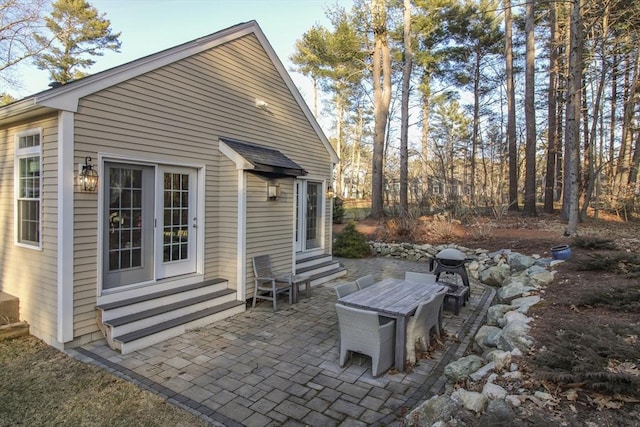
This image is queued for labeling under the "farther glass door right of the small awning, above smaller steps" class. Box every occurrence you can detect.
[296,180,324,252]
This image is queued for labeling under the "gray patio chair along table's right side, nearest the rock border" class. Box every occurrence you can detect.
[406,286,447,363]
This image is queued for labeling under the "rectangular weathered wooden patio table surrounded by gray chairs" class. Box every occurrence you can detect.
[338,278,443,372]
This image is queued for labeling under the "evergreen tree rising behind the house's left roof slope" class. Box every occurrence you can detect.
[35,0,121,83]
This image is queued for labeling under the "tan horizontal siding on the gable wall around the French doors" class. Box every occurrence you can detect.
[65,35,330,338]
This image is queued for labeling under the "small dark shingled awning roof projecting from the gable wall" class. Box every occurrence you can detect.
[220,138,307,177]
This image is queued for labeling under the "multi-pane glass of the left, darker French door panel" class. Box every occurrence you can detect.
[108,167,143,271]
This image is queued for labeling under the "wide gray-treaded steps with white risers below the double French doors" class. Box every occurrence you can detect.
[96,279,246,354]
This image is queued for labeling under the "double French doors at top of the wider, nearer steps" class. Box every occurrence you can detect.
[102,162,197,289]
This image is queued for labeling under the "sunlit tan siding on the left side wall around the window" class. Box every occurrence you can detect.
[0,117,58,346]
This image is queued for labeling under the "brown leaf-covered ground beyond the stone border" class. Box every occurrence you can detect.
[342,214,640,427]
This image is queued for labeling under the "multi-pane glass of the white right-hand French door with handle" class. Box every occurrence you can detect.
[162,172,189,262]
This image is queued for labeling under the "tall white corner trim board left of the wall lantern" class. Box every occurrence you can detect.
[57,111,75,343]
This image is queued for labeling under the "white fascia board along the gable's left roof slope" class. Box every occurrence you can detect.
[35,21,258,112]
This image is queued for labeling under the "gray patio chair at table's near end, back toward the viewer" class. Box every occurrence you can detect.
[336,303,396,377]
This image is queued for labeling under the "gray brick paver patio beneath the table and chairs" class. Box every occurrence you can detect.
[69,258,495,427]
